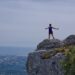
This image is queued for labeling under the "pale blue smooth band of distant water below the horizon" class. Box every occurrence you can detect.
[0,47,35,56]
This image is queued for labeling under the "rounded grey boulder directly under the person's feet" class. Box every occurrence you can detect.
[37,39,62,50]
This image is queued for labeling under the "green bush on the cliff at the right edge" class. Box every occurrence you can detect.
[62,46,75,75]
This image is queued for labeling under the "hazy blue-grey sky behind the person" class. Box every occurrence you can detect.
[0,0,75,47]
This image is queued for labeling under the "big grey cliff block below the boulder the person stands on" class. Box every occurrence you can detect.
[27,50,65,75]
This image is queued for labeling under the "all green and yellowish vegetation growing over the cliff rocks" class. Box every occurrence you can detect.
[43,45,75,75]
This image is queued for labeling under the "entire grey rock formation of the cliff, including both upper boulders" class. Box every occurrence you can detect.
[26,35,75,75]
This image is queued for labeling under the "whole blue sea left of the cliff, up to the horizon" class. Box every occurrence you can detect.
[0,47,34,75]
